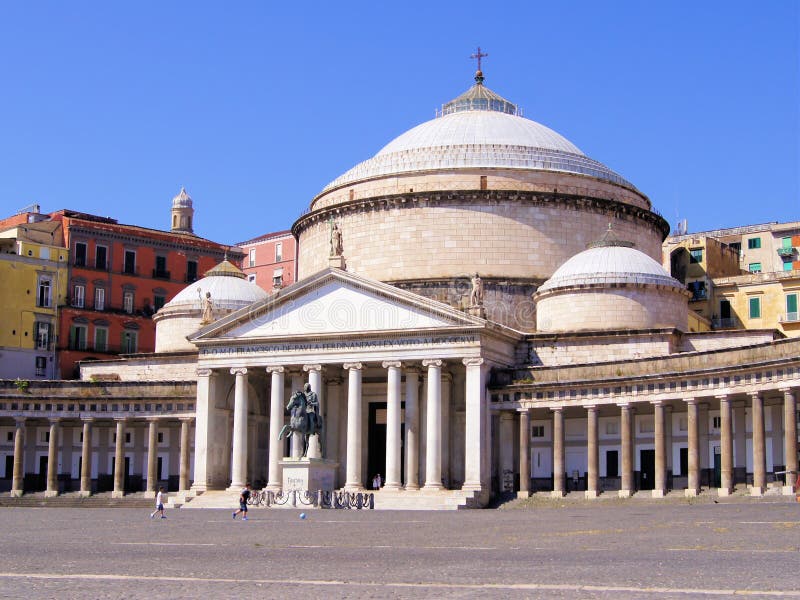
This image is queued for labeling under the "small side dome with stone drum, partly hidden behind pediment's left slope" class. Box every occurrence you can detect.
[153,259,269,352]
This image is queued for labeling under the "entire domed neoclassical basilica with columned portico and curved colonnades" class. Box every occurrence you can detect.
[0,70,800,508]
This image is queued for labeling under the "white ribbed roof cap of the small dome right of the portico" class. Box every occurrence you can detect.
[538,246,683,292]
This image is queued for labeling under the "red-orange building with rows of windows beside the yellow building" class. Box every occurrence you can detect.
[43,210,241,379]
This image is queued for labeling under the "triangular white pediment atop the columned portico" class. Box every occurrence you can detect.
[191,269,486,343]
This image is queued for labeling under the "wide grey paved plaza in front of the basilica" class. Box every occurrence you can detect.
[0,498,800,598]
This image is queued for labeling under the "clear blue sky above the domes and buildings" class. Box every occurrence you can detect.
[0,0,800,243]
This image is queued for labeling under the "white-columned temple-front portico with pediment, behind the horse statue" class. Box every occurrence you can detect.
[185,269,518,503]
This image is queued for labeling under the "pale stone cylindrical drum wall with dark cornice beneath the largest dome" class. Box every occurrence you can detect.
[295,191,663,282]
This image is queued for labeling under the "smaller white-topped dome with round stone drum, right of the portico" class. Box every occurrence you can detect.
[533,229,690,332]
